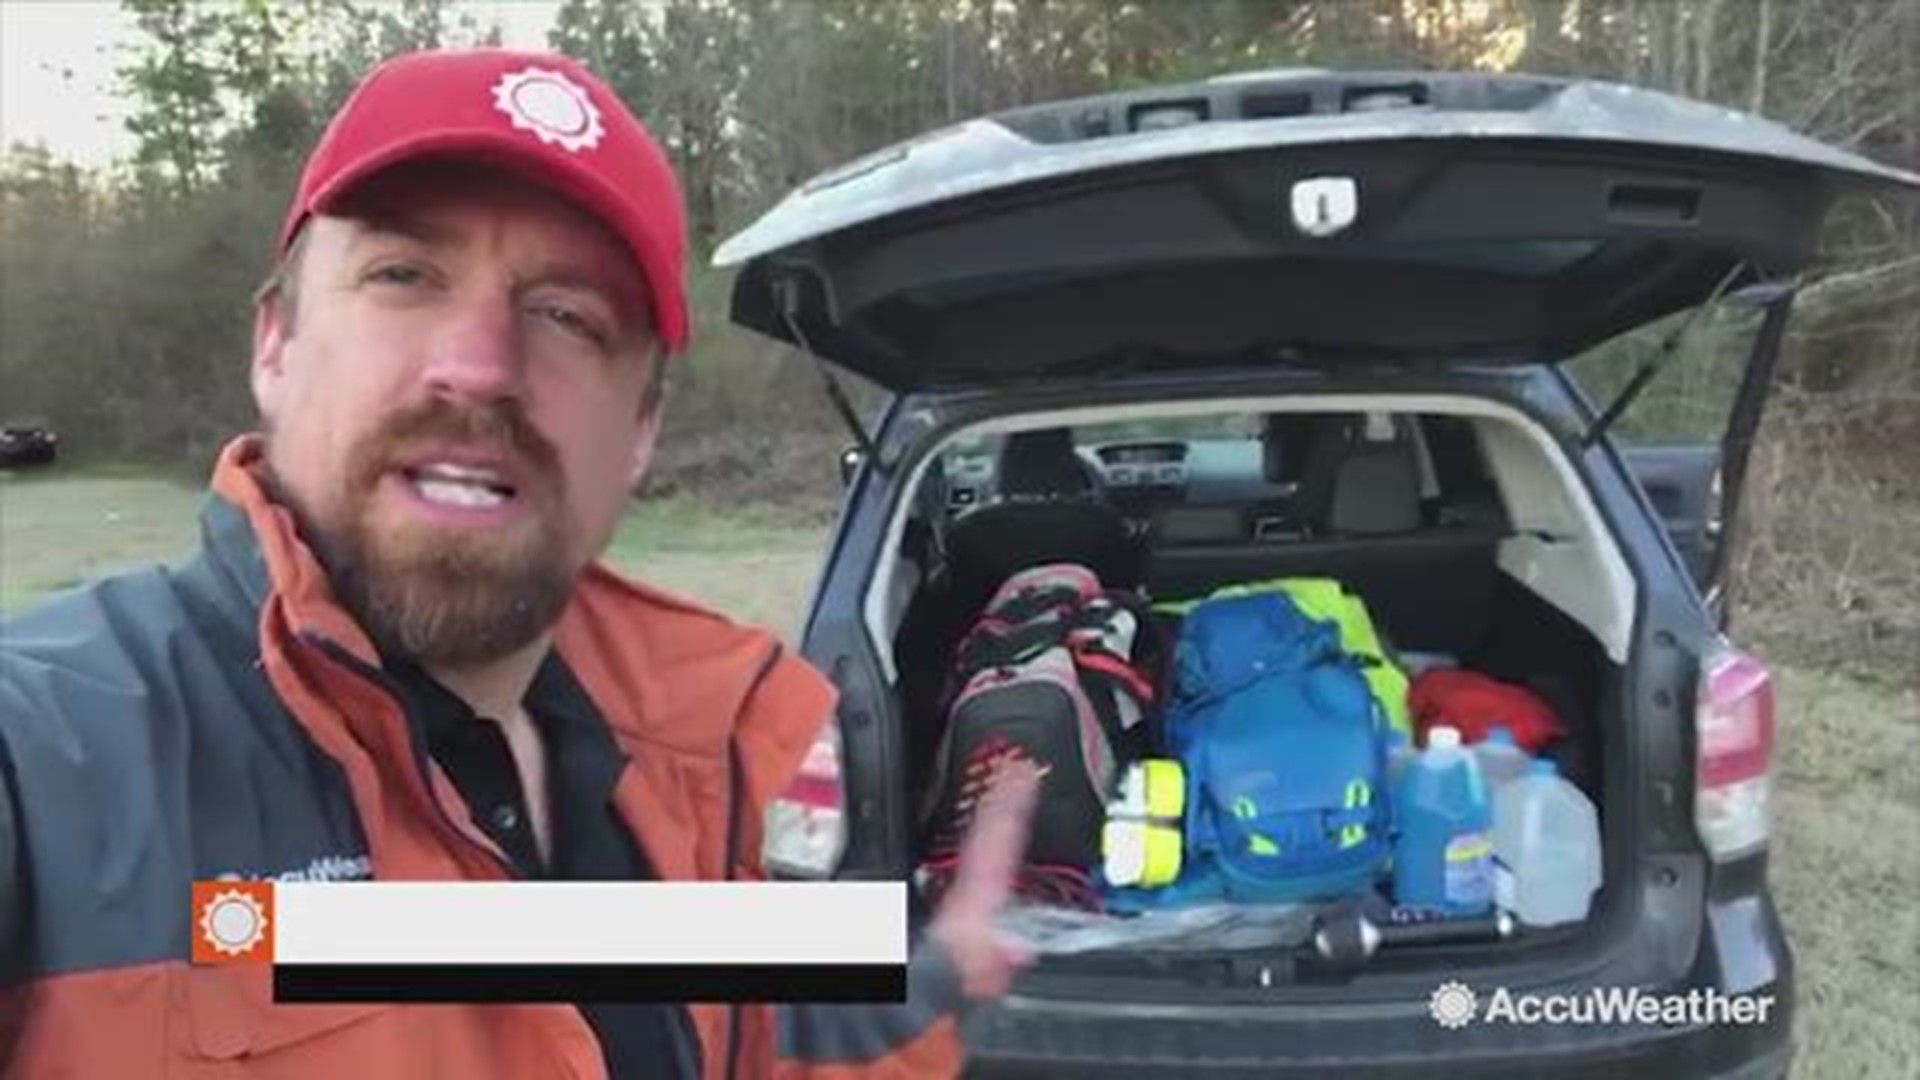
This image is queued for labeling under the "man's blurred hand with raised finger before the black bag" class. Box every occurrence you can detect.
[927,765,1041,999]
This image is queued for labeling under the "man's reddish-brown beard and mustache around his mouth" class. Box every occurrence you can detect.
[267,402,580,669]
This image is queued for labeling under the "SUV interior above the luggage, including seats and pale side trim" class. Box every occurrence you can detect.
[881,399,1632,868]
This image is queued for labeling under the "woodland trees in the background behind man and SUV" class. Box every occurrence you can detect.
[0,0,1920,478]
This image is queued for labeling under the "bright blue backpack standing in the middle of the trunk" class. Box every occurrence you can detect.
[1164,592,1390,901]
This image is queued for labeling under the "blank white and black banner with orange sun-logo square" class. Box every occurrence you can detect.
[192,882,908,1001]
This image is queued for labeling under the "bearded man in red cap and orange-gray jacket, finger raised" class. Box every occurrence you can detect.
[0,50,1033,1076]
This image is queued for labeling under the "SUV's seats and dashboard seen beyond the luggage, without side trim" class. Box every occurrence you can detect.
[927,413,1509,646]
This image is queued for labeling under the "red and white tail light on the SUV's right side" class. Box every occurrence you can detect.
[1693,650,1774,863]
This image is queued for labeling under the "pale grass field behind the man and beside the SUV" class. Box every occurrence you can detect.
[0,473,1920,1080]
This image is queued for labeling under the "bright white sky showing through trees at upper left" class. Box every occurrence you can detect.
[0,0,561,167]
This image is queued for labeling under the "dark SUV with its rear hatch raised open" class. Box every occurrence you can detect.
[716,71,1920,1078]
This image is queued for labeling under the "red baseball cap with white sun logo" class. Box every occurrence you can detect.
[280,48,687,352]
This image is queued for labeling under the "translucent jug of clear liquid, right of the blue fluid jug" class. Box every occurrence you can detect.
[1494,757,1599,926]
